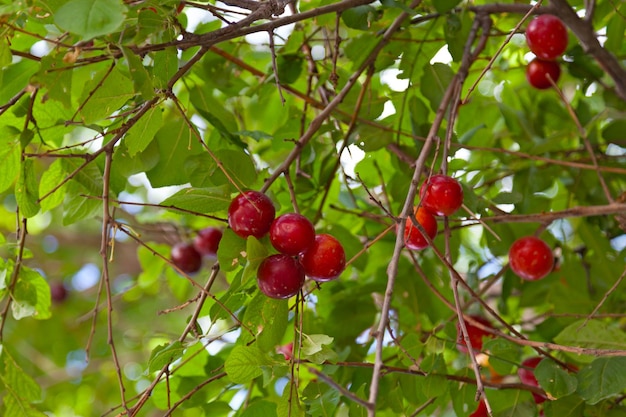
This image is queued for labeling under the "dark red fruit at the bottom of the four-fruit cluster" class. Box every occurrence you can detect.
[257,254,304,299]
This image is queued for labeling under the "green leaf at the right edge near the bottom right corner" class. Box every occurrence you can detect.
[577,357,626,404]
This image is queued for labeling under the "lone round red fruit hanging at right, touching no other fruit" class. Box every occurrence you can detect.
[509,236,554,281]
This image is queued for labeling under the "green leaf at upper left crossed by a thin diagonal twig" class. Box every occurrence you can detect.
[78,66,135,125]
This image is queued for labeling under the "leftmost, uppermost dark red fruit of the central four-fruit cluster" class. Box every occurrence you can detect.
[228,191,276,239]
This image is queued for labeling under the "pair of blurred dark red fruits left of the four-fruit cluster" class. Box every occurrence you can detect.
[170,227,222,274]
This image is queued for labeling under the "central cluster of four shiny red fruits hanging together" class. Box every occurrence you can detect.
[228,191,346,299]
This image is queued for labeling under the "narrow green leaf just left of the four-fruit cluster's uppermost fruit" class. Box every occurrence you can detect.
[161,186,231,214]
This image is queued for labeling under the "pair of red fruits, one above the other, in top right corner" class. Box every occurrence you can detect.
[526,14,567,90]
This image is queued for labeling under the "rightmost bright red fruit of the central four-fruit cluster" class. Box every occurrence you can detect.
[300,234,346,282]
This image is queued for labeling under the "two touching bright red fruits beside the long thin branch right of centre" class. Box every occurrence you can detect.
[404,174,463,250]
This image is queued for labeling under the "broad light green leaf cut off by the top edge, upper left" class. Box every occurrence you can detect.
[54,0,126,39]
